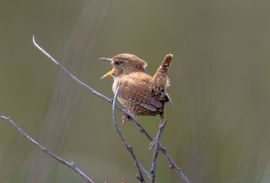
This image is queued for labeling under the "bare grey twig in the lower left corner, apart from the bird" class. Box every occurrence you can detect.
[0,114,95,183]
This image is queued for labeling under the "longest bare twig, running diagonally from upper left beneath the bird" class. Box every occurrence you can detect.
[32,36,190,183]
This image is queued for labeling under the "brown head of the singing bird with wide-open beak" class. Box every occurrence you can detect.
[100,53,147,79]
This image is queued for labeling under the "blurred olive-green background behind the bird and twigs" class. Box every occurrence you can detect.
[0,0,270,183]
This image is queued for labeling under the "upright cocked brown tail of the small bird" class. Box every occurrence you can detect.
[152,54,173,90]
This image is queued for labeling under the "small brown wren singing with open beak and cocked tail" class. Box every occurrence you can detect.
[100,53,173,123]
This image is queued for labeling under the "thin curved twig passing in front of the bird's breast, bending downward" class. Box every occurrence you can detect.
[112,87,144,182]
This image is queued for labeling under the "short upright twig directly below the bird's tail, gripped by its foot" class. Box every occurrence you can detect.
[150,114,167,183]
